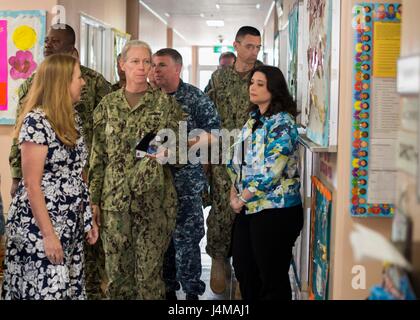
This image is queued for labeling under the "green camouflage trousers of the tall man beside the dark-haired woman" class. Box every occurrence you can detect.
[206,165,235,259]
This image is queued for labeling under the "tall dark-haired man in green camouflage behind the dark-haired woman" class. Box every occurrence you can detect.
[206,26,262,293]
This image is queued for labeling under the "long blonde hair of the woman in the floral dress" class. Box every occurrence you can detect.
[15,54,79,147]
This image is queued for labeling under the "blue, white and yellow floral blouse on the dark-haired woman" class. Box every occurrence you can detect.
[228,110,302,214]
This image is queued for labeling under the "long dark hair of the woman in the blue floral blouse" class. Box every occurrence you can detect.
[248,66,298,117]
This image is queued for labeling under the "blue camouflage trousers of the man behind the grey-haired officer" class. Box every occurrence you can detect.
[163,193,206,295]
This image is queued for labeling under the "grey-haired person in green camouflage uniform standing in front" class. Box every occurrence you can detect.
[89,40,186,300]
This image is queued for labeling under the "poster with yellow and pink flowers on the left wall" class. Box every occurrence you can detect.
[0,10,46,125]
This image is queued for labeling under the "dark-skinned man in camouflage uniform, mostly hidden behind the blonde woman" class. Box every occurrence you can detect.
[9,24,111,299]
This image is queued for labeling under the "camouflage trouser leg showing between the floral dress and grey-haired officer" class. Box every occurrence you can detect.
[84,237,105,300]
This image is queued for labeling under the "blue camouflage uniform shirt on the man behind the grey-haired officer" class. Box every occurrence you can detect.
[173,80,220,196]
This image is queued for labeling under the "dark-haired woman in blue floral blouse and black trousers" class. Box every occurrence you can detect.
[228,66,303,300]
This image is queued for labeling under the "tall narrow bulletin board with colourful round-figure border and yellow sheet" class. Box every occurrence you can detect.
[350,3,402,217]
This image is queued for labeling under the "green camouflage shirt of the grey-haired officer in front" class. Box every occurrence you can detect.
[89,87,185,212]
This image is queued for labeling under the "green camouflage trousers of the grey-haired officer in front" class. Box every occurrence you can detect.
[101,195,177,300]
